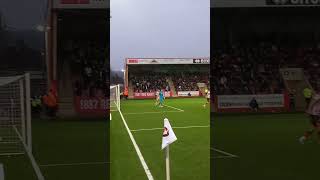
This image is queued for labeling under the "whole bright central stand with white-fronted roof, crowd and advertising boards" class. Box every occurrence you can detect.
[125,58,210,99]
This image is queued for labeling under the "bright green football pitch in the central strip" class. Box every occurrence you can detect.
[110,98,210,180]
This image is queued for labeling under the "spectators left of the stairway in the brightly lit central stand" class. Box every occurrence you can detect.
[129,73,170,92]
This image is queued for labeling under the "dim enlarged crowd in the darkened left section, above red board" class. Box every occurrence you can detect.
[64,40,109,97]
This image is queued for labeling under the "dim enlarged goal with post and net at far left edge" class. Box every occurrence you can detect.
[0,75,32,155]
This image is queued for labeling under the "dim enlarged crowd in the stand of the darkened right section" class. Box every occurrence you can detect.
[212,42,320,94]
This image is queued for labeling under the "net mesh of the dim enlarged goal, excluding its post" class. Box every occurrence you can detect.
[0,76,25,155]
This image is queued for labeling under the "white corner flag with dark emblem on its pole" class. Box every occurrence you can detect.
[161,118,177,180]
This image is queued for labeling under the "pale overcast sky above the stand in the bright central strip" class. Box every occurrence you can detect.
[110,0,210,70]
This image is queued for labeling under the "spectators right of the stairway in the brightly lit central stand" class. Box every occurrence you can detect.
[172,72,209,91]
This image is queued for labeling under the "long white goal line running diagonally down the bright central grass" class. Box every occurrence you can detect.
[118,106,154,180]
